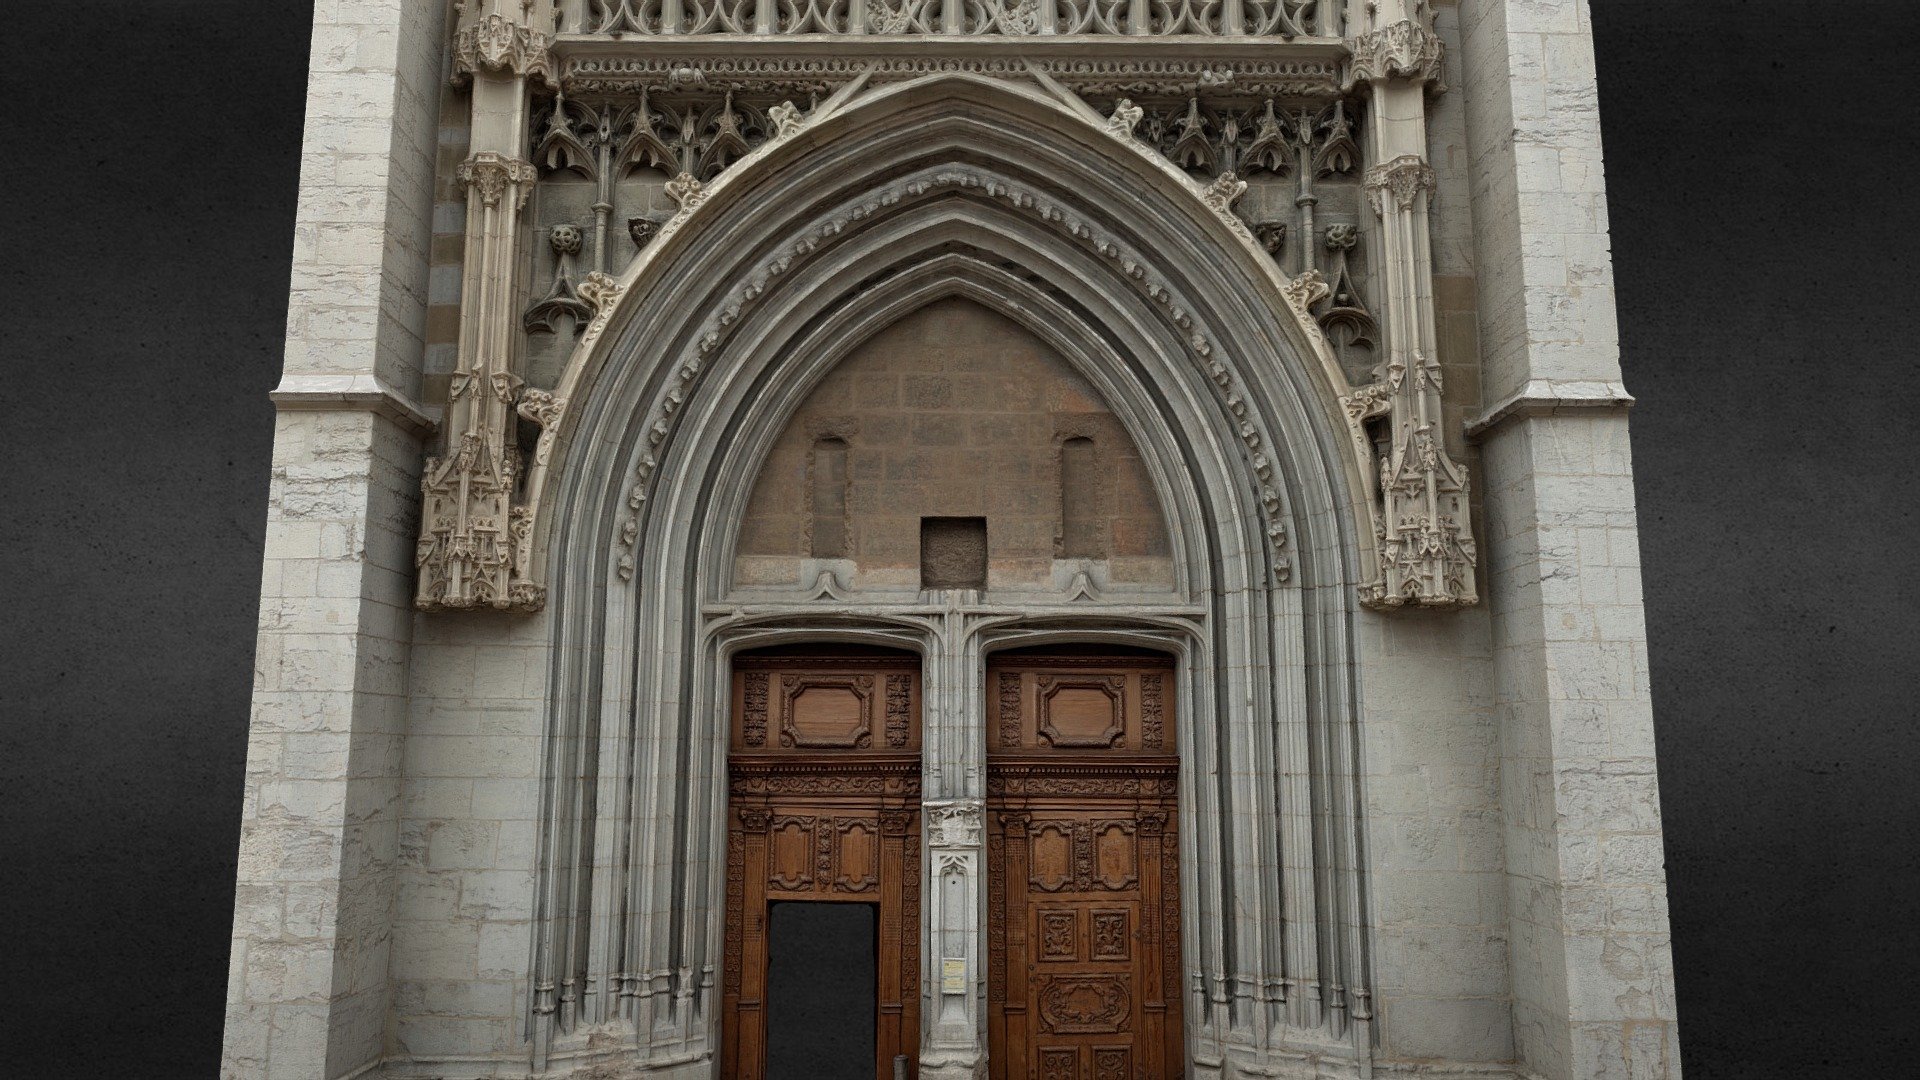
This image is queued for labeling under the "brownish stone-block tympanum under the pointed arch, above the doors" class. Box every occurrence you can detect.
[733,300,1173,594]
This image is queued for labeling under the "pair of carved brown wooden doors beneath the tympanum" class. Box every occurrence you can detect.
[722,651,1185,1080]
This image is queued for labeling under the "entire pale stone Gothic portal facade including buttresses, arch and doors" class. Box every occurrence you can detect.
[223,0,1680,1080]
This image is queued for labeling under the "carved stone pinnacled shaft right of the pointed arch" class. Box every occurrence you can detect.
[1346,154,1478,607]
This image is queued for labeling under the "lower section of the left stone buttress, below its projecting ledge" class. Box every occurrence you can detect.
[223,411,419,1078]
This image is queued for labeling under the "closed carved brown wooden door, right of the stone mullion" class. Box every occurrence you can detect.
[987,653,1183,1080]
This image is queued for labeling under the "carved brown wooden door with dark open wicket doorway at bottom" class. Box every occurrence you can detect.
[722,648,920,1080]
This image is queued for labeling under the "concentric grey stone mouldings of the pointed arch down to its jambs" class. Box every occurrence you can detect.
[530,77,1373,1063]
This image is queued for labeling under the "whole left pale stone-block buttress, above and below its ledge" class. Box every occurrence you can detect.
[221,0,444,1080]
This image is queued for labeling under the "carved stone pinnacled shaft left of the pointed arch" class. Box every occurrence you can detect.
[415,150,545,611]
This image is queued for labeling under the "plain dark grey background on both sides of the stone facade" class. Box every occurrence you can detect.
[0,0,1920,1080]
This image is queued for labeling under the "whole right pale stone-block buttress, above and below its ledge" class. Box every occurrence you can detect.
[1461,0,1680,1080]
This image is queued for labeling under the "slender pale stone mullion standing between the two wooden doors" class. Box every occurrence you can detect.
[920,590,987,1080]
